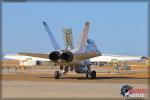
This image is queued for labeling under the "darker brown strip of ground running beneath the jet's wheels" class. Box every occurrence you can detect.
[1,73,149,84]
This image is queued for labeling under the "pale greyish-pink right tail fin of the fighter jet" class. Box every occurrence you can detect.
[77,22,90,52]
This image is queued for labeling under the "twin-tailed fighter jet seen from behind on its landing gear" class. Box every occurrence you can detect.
[19,22,101,79]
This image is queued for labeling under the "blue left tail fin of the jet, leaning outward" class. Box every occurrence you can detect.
[43,22,60,50]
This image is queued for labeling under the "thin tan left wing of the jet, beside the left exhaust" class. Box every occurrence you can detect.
[18,53,49,59]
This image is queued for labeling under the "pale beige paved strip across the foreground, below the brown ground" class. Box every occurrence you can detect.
[2,81,147,98]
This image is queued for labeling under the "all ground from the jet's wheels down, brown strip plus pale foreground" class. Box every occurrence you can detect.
[2,74,148,99]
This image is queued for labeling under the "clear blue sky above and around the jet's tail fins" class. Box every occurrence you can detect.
[2,2,148,56]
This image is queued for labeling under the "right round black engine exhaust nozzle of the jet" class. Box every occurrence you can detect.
[61,51,73,62]
